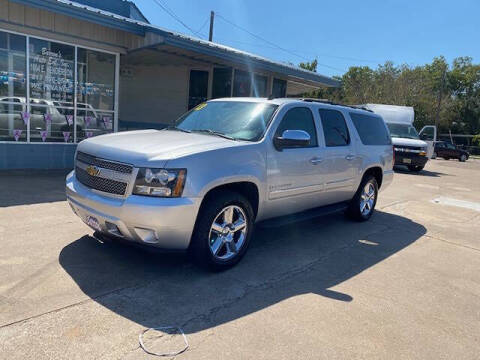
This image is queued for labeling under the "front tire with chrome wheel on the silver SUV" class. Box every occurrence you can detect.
[189,191,254,271]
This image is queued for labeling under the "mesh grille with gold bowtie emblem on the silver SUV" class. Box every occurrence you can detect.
[75,152,133,196]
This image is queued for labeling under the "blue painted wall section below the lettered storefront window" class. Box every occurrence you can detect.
[0,143,77,170]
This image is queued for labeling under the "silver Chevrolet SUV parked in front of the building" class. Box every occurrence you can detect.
[66,98,393,270]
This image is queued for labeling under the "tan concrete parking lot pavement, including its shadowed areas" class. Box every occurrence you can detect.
[0,159,480,359]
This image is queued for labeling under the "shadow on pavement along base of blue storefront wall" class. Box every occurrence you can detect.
[0,170,70,207]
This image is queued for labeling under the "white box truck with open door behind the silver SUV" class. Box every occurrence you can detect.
[362,104,437,172]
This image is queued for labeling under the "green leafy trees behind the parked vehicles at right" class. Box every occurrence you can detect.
[300,56,480,134]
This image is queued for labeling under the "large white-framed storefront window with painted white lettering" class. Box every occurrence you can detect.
[0,31,118,143]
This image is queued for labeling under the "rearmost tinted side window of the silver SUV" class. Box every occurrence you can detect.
[350,113,391,145]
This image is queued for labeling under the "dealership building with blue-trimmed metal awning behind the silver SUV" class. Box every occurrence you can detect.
[0,0,338,169]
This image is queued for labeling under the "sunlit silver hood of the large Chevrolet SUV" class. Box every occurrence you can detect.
[78,130,241,167]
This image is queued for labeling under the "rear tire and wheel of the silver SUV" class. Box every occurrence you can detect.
[347,175,378,221]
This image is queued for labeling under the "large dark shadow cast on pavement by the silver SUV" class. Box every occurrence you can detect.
[59,211,426,333]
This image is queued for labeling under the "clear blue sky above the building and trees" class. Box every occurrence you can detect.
[133,0,480,76]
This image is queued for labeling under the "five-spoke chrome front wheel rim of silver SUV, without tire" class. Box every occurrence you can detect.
[208,205,248,260]
